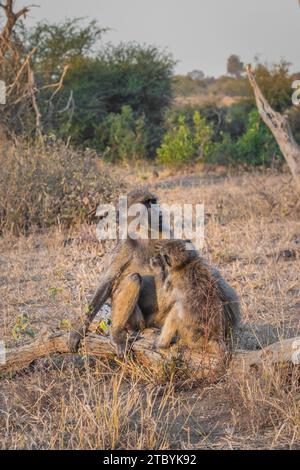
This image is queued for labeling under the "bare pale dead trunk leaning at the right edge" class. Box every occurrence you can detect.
[246,65,300,193]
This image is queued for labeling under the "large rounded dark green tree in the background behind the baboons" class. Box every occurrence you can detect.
[39,43,174,155]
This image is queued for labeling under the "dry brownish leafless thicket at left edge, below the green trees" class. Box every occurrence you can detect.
[0,140,125,235]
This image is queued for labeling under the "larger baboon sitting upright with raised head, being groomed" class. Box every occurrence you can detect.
[69,189,240,355]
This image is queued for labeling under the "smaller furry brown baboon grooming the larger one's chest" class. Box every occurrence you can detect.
[150,240,230,348]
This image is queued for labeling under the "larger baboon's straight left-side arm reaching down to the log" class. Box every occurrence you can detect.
[69,244,132,352]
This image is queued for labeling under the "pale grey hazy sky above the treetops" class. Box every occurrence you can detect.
[12,0,300,76]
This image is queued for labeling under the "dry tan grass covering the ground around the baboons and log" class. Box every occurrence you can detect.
[0,168,300,449]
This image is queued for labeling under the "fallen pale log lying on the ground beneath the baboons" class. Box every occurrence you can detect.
[0,329,300,377]
